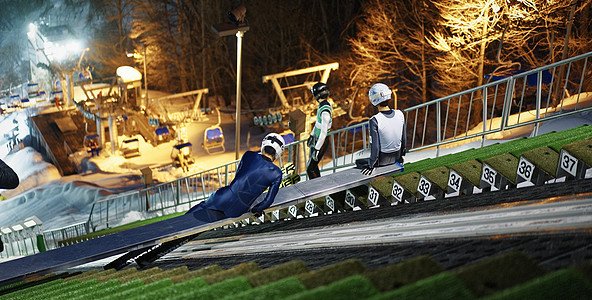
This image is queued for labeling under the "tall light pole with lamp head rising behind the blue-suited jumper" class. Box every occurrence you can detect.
[212,5,249,160]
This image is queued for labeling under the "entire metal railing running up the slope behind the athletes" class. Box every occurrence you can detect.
[39,52,592,250]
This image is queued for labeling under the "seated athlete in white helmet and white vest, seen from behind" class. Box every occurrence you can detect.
[356,83,407,175]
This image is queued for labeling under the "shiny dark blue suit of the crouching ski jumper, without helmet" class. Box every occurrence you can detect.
[187,151,282,222]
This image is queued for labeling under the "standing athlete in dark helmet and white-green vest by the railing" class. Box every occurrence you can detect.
[306,82,333,179]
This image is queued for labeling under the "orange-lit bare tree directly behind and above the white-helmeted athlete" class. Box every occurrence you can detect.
[349,0,436,102]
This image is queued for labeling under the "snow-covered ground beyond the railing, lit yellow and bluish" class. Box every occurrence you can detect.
[0,97,592,230]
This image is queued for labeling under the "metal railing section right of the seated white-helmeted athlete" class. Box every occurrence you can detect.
[403,52,592,155]
